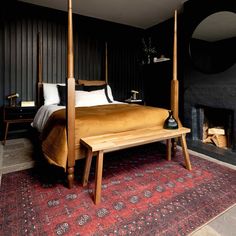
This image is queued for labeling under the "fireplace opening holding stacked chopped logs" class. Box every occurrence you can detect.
[196,106,234,149]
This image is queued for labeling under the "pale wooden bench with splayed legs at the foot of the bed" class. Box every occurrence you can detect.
[81,127,191,204]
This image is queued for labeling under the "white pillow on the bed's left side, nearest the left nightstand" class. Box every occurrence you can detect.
[43,83,65,105]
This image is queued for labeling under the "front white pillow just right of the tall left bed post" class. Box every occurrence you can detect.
[75,89,109,107]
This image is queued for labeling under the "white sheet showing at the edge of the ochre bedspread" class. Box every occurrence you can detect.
[31,101,123,133]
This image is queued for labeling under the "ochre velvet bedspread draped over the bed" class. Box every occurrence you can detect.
[42,104,168,170]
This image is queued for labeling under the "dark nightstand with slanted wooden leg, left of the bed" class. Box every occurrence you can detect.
[2,106,37,145]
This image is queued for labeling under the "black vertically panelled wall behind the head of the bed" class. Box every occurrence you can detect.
[0,0,143,106]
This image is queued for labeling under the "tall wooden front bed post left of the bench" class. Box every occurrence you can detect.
[66,0,75,188]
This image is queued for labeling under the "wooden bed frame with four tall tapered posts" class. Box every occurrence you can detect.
[37,0,191,188]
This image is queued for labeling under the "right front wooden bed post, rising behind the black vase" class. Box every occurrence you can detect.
[171,10,182,156]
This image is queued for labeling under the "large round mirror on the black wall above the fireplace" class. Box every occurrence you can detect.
[189,11,236,74]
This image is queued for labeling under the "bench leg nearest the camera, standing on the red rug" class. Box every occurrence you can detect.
[94,151,103,205]
